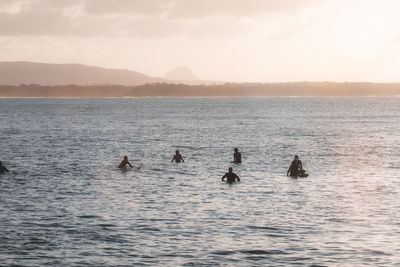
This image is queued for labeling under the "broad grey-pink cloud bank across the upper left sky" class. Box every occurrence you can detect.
[0,0,322,38]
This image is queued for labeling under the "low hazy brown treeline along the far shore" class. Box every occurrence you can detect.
[0,82,400,97]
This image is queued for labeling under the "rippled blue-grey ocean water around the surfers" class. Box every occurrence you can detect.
[0,98,400,266]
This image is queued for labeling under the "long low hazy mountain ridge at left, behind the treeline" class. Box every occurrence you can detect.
[0,62,167,85]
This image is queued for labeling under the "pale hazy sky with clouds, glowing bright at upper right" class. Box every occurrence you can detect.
[0,0,400,82]
